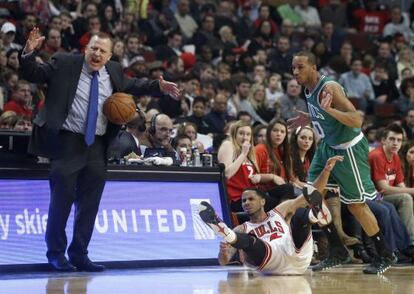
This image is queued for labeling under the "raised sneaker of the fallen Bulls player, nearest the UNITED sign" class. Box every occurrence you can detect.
[198,201,235,241]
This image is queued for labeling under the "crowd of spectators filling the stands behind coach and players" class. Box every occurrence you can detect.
[0,0,414,264]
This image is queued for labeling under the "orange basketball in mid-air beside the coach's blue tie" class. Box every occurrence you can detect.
[102,92,136,125]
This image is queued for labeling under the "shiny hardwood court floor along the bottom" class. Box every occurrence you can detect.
[0,265,414,294]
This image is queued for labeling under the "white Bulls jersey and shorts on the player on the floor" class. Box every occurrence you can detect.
[243,209,313,275]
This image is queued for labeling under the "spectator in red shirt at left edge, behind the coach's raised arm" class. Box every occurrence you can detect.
[3,80,33,119]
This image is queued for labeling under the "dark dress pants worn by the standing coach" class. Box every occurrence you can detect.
[46,131,106,259]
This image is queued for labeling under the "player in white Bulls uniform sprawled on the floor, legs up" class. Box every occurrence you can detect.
[199,156,342,275]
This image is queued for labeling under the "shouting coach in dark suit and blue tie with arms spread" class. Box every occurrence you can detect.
[20,28,179,271]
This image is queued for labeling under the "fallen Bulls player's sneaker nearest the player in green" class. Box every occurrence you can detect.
[303,185,332,226]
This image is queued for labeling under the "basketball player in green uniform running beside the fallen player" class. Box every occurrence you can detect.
[288,52,392,274]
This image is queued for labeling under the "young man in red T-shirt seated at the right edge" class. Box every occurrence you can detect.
[369,124,414,244]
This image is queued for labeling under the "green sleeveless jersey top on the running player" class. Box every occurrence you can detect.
[305,76,361,146]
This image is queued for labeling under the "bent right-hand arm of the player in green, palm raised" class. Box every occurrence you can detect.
[319,83,363,128]
